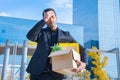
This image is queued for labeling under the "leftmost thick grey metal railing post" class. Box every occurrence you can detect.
[2,40,10,80]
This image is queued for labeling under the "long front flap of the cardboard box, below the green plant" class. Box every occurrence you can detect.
[48,48,71,57]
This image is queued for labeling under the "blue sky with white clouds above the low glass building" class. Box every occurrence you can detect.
[0,0,73,24]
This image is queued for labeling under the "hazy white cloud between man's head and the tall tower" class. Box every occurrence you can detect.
[47,0,73,24]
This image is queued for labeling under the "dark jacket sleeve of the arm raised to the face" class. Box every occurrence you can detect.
[26,19,45,41]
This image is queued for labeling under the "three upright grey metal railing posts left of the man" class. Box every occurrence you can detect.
[1,40,28,80]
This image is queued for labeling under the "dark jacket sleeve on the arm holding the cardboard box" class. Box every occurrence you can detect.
[69,33,88,64]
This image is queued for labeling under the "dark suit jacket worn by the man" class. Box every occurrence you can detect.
[27,20,87,74]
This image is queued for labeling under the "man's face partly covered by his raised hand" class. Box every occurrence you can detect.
[43,11,57,27]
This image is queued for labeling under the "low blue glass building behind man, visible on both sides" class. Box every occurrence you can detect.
[0,16,83,45]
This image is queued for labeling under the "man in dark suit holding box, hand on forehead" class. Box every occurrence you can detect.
[27,8,87,80]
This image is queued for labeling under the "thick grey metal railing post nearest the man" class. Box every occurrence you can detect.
[20,40,28,80]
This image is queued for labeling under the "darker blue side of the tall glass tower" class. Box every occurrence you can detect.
[73,0,98,43]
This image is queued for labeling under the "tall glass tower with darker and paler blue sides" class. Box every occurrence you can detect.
[73,0,120,80]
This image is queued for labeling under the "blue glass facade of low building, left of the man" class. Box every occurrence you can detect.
[0,16,36,44]
